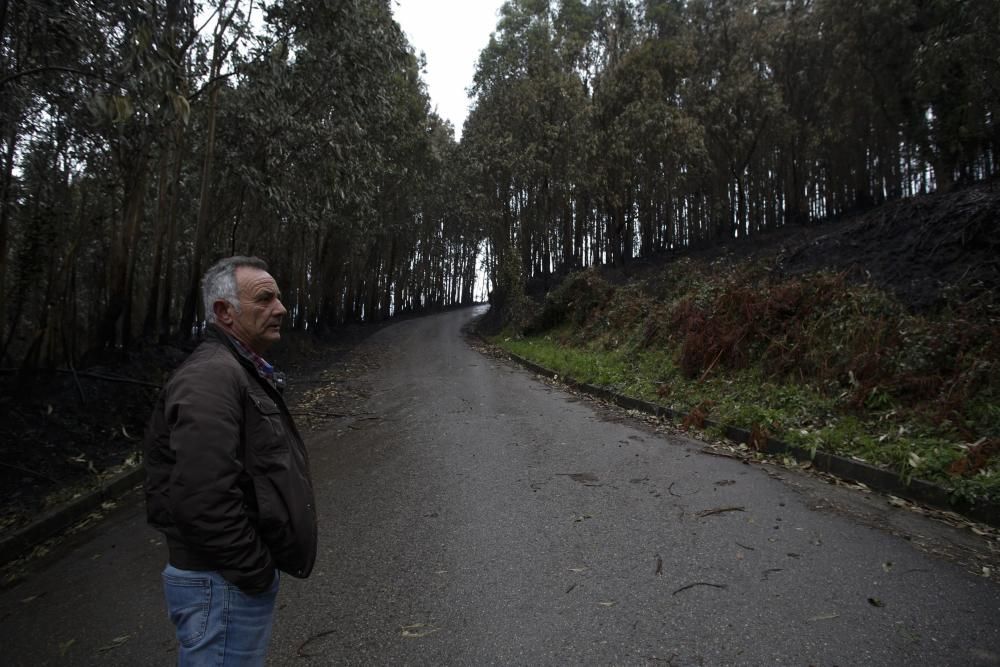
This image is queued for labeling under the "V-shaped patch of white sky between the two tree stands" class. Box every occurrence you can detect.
[392,0,503,138]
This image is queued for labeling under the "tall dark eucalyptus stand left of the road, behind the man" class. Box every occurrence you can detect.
[0,0,481,371]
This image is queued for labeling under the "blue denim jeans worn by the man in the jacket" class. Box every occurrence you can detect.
[163,565,279,667]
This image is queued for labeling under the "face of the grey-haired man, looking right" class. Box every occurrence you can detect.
[228,266,288,354]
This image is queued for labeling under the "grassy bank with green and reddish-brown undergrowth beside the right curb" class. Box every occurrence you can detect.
[496,260,1000,502]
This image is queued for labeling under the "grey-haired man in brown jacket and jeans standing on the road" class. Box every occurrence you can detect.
[144,257,316,665]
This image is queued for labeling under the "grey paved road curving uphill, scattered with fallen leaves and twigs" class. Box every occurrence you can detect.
[0,310,1000,666]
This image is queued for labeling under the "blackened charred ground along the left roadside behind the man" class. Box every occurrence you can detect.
[0,325,377,537]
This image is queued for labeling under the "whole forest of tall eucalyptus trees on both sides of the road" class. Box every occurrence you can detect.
[0,0,1000,371]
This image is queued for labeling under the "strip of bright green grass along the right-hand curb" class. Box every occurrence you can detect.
[493,335,1000,501]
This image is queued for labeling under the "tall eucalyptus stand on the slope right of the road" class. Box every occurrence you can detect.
[462,0,1000,324]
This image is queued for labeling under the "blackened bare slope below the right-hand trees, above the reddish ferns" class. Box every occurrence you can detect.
[588,181,1000,310]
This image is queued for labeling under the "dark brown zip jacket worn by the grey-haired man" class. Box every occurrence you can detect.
[144,325,317,593]
